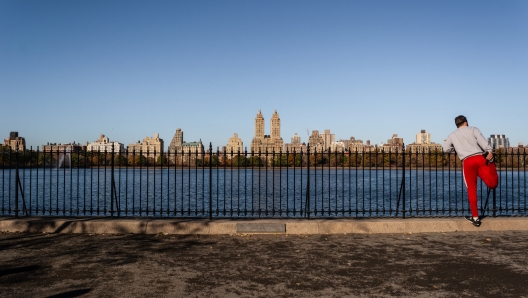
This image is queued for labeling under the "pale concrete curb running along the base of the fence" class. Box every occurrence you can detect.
[0,217,528,235]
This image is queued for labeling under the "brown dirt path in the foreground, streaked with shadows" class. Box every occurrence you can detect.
[0,232,528,297]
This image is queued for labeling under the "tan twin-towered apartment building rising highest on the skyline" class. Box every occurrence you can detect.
[251,109,284,154]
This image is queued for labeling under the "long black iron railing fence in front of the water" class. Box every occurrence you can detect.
[0,146,528,218]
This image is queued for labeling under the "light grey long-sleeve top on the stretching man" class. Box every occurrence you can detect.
[443,126,493,160]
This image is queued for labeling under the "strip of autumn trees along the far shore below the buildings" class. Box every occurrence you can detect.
[0,146,528,169]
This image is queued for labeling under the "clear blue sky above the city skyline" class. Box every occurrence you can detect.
[0,0,528,148]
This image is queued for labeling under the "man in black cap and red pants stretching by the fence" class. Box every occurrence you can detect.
[443,115,499,227]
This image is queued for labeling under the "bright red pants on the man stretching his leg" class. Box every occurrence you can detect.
[462,155,499,217]
